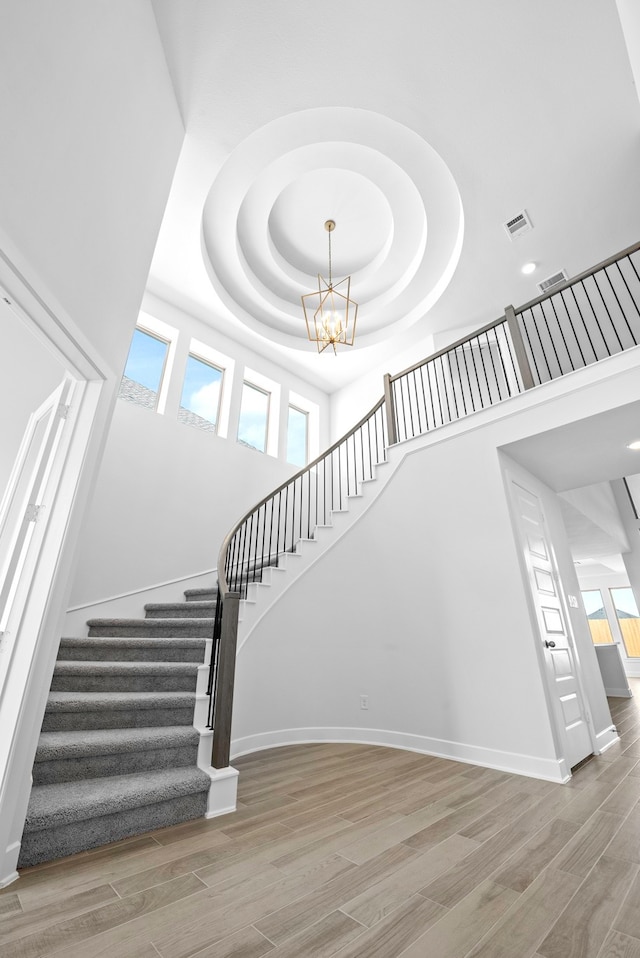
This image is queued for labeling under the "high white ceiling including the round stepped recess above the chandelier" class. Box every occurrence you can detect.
[149,0,640,392]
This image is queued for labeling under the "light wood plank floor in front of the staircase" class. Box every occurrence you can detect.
[0,680,640,958]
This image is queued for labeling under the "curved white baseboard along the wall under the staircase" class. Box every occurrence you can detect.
[231,728,570,783]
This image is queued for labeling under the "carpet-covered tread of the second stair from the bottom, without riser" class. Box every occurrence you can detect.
[36,725,200,762]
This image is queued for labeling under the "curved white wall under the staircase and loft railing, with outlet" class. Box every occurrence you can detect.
[233,354,640,777]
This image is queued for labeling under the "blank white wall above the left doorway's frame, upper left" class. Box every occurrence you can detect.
[0,0,183,372]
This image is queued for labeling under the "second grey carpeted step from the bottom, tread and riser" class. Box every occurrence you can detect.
[33,725,199,785]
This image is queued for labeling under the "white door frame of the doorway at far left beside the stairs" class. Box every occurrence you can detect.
[0,244,110,887]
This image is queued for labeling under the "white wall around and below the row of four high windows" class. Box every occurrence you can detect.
[70,296,328,616]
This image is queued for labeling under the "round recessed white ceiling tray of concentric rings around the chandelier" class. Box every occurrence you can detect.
[202,107,463,349]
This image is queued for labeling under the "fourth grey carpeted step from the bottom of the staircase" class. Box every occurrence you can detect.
[51,660,198,692]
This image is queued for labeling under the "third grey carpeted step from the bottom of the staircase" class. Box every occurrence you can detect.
[42,692,195,732]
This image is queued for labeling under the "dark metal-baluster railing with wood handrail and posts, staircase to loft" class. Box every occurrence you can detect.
[209,243,640,768]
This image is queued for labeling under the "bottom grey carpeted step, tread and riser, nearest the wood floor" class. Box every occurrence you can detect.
[18,768,210,867]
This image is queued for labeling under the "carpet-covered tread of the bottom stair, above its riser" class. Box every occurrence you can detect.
[25,767,210,832]
